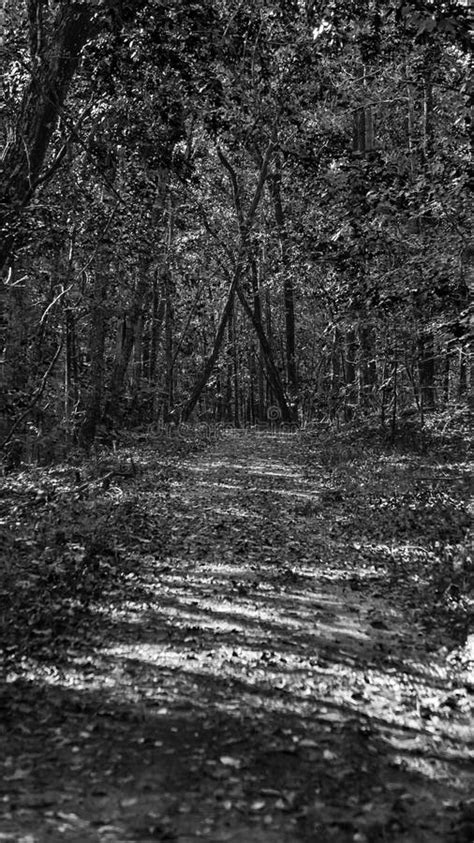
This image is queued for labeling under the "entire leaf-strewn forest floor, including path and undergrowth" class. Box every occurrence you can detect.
[0,431,474,843]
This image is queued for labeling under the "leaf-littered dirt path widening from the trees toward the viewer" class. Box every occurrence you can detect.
[0,432,474,843]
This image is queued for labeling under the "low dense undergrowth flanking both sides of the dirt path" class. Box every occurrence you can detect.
[0,417,473,664]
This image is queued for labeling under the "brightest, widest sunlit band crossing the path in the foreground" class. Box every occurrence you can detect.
[94,635,469,744]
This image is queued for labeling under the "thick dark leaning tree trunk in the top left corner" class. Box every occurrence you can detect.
[0,0,152,272]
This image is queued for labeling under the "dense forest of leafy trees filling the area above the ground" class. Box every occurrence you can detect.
[0,0,472,454]
